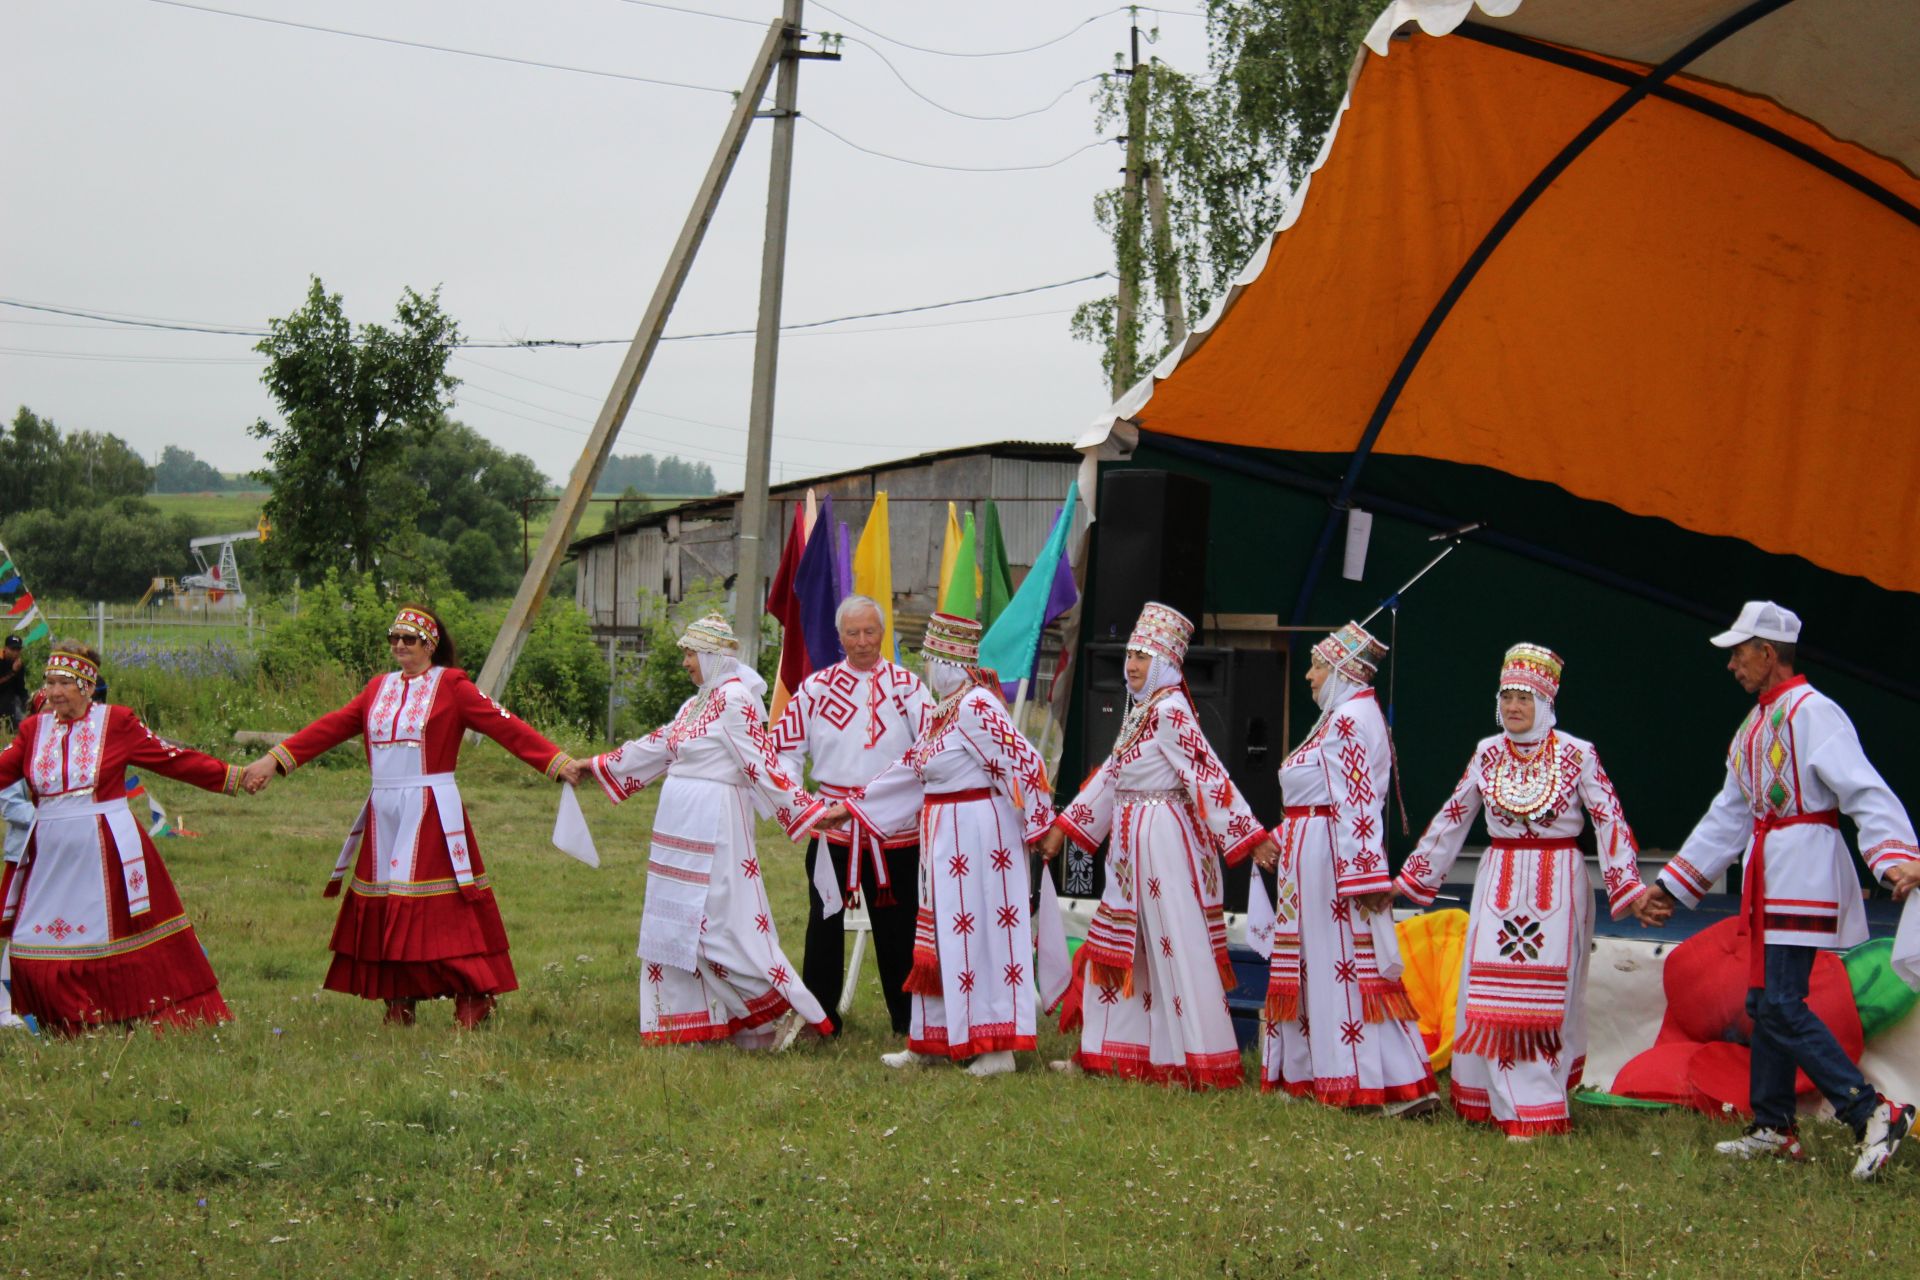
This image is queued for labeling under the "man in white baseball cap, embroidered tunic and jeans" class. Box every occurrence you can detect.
[1649,601,1920,1182]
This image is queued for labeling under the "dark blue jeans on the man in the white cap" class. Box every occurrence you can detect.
[1747,944,1880,1134]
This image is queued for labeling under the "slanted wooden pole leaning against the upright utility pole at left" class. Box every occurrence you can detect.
[478,20,797,697]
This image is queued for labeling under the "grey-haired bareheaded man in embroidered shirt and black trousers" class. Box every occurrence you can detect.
[774,595,933,1036]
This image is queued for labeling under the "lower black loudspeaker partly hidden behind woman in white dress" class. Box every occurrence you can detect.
[1060,640,1286,912]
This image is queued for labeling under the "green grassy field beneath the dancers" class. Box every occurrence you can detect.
[0,756,1920,1280]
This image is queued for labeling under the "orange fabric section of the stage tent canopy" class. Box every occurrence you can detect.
[1129,26,1920,591]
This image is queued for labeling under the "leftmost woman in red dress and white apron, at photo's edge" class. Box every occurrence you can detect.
[0,641,240,1034]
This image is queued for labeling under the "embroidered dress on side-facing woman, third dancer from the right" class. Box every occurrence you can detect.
[1261,689,1438,1107]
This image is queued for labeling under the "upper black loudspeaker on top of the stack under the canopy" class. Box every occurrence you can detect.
[1087,470,1212,641]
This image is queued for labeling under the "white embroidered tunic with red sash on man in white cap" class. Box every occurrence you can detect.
[1661,676,1920,948]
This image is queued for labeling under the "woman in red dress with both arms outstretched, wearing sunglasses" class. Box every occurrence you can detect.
[246,606,572,1027]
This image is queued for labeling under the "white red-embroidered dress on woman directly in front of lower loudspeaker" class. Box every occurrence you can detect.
[1054,687,1265,1088]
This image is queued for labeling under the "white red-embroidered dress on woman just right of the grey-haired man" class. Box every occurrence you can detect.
[847,685,1054,1057]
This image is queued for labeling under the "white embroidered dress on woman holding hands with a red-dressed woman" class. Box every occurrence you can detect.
[589,677,828,1044]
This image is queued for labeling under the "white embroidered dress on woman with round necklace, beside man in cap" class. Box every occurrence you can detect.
[1396,729,1647,1136]
